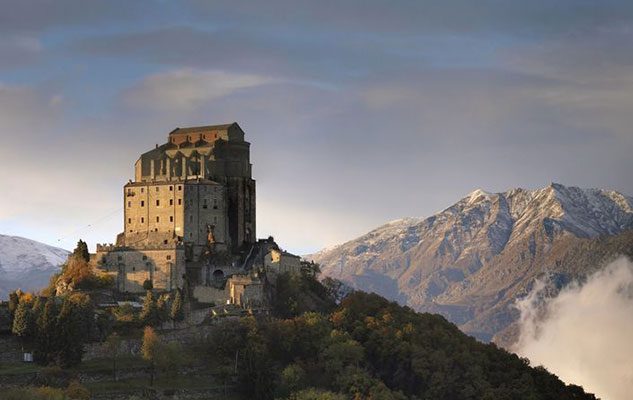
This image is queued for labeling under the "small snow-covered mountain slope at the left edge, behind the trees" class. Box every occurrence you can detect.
[0,235,69,299]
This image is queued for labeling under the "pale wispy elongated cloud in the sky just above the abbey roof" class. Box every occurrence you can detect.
[124,68,272,110]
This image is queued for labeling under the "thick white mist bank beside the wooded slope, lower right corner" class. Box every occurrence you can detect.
[514,258,633,400]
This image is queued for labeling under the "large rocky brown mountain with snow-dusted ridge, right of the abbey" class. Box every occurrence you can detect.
[305,183,633,346]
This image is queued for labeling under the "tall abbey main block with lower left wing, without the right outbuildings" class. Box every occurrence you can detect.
[95,123,256,291]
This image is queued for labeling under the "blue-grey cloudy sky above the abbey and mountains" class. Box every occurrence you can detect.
[0,0,633,254]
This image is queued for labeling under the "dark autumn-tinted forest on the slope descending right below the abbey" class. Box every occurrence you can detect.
[200,292,595,400]
